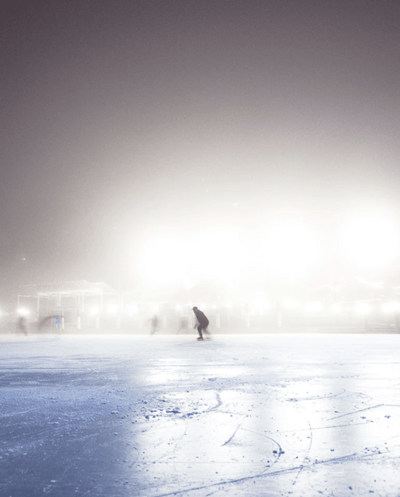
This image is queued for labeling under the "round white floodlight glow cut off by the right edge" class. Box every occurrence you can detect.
[340,214,400,269]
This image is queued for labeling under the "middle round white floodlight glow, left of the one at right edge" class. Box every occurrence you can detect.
[259,222,318,276]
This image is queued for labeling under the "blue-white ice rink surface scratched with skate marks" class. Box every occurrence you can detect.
[0,333,400,497]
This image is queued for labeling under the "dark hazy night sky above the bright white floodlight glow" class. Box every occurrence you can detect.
[0,0,400,299]
